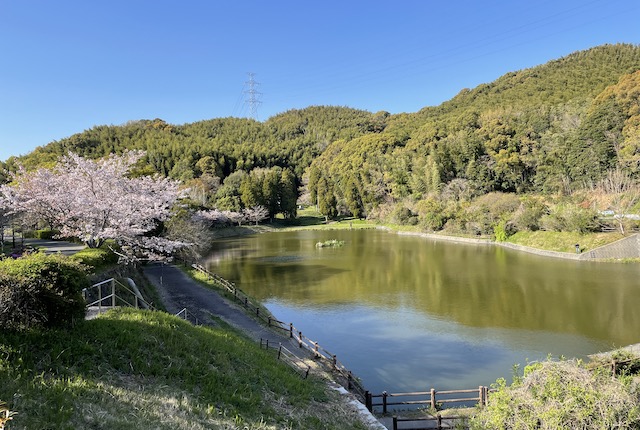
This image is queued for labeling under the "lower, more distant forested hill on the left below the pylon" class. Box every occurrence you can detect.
[7,107,376,180]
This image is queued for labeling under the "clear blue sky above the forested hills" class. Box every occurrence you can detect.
[0,0,640,160]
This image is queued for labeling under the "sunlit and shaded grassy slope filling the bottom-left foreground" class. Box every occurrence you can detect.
[0,309,364,430]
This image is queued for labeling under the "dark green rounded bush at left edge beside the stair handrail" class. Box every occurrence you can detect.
[0,253,89,330]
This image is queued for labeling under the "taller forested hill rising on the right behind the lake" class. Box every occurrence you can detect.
[309,45,640,217]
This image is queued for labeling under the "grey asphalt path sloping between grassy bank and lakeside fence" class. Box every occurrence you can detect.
[144,264,310,358]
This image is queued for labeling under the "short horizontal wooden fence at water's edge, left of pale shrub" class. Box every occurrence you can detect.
[365,386,489,414]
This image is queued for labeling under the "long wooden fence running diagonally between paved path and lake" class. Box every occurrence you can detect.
[191,264,367,400]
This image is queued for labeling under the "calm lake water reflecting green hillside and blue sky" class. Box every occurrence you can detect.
[204,230,640,393]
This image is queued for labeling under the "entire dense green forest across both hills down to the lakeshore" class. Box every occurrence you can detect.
[5,44,640,234]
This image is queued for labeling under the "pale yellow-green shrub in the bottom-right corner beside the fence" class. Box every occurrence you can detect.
[472,361,640,430]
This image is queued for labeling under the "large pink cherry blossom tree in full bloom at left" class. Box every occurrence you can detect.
[0,151,184,257]
